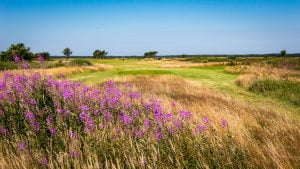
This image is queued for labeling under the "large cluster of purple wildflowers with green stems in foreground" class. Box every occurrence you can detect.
[0,73,228,165]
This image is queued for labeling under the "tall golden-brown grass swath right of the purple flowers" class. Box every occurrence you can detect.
[110,75,300,168]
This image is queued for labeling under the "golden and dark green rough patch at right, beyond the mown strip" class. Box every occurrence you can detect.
[224,64,300,106]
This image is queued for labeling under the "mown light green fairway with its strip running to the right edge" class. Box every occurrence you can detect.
[68,59,300,113]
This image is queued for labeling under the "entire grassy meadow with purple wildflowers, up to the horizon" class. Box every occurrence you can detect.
[0,57,300,168]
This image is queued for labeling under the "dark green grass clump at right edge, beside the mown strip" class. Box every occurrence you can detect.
[249,79,300,106]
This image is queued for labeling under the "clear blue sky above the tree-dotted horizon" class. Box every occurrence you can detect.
[0,0,300,55]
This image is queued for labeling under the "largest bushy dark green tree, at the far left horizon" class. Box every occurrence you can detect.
[0,43,34,61]
